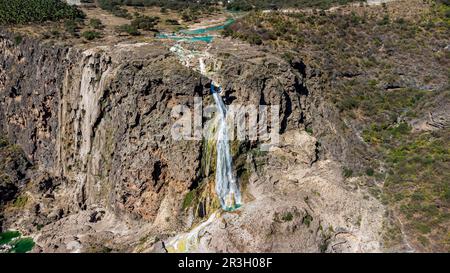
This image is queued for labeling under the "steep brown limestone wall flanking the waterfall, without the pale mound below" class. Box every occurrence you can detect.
[0,32,308,229]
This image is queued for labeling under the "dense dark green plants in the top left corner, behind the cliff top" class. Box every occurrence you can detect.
[0,0,84,24]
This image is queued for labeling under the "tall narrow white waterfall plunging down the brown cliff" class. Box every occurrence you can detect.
[211,83,241,210]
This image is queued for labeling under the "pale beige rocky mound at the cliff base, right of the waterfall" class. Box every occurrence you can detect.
[169,131,384,252]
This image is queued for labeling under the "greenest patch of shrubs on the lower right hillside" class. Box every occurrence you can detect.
[384,129,450,248]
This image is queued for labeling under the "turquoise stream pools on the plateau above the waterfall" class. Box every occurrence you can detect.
[156,19,235,43]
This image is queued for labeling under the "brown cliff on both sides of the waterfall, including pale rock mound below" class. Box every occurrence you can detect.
[0,32,382,252]
